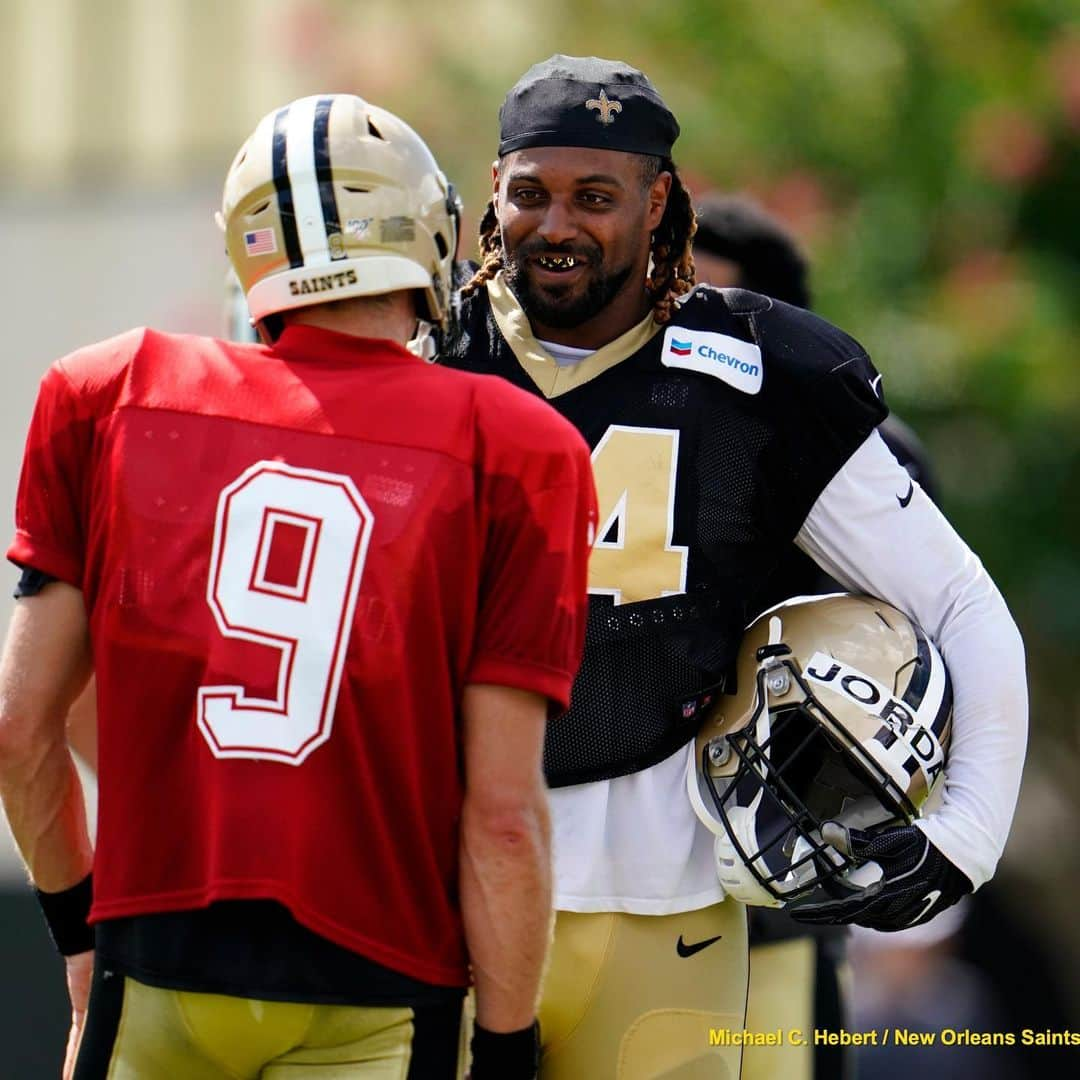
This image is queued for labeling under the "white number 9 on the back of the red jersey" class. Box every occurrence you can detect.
[198,461,374,765]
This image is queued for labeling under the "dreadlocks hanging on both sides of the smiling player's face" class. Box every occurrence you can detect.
[461,156,698,324]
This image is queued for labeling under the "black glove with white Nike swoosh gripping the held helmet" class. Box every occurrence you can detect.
[786,822,974,930]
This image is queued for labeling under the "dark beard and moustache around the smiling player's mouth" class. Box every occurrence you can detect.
[502,243,634,330]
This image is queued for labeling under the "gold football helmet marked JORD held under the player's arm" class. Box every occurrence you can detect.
[687,594,953,907]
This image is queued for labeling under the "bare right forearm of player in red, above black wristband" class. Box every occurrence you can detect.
[461,798,552,1031]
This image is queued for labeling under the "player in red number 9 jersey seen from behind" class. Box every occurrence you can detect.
[0,95,595,1080]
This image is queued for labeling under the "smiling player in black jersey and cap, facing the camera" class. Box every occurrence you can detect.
[445,56,1027,1080]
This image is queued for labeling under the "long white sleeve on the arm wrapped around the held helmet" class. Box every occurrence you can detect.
[795,432,1027,889]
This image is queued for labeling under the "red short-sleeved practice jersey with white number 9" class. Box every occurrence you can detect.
[9,326,595,985]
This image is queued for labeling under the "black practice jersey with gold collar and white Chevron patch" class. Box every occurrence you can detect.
[444,275,887,786]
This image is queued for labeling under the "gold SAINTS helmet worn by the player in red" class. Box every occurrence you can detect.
[218,94,460,337]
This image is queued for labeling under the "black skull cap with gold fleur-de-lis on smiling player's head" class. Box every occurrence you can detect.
[499,54,678,158]
